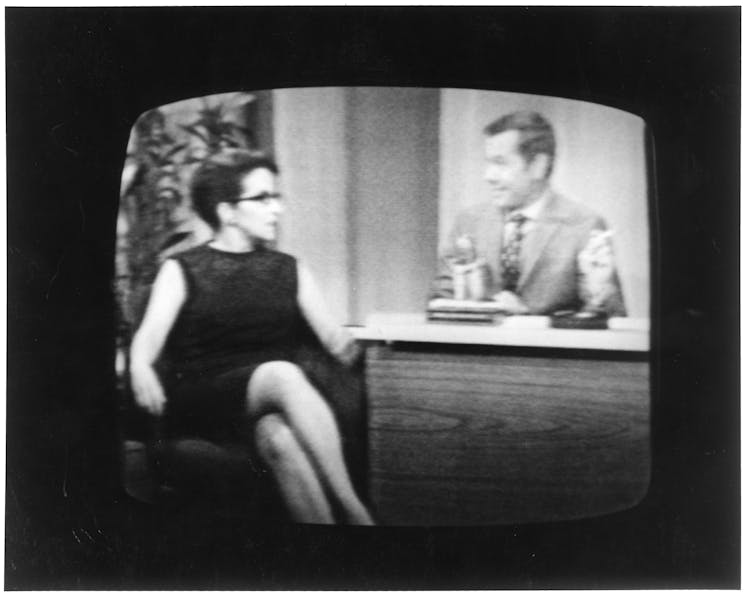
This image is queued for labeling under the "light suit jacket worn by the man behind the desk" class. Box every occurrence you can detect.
[432,191,626,316]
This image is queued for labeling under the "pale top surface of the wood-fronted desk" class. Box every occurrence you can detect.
[349,313,649,352]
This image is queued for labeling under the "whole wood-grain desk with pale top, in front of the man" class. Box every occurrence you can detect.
[356,315,650,525]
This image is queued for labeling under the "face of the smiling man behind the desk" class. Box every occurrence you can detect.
[484,130,546,210]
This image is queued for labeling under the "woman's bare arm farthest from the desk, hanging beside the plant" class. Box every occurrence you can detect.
[131,260,186,414]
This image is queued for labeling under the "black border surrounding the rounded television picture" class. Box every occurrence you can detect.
[5,7,741,589]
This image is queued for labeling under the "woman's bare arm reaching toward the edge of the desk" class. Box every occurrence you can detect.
[298,261,359,365]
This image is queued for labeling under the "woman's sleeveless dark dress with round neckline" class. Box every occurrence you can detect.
[162,245,300,442]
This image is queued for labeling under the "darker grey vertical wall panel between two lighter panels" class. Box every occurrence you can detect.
[346,88,440,322]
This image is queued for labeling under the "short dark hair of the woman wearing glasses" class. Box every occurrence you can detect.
[191,148,278,230]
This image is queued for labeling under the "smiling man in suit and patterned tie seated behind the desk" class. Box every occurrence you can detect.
[432,111,625,316]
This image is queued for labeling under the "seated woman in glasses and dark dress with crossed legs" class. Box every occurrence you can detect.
[131,150,373,525]
